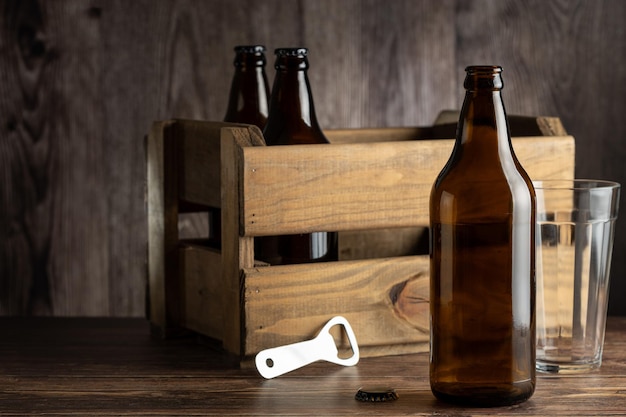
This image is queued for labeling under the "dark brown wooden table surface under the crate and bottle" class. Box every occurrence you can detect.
[0,317,626,416]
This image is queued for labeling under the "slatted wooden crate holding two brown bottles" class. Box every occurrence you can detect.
[147,113,574,359]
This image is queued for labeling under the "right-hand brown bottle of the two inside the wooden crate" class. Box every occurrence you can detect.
[254,48,338,265]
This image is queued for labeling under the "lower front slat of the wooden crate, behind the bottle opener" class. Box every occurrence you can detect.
[244,256,429,355]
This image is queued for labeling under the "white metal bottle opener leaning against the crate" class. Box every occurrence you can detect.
[254,316,359,379]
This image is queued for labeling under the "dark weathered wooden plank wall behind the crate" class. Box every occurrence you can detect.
[0,0,626,316]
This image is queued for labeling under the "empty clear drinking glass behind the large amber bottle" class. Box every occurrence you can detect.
[533,180,620,373]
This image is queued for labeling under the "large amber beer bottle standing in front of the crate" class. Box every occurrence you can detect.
[430,66,535,406]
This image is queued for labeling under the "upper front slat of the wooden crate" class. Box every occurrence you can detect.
[242,137,574,236]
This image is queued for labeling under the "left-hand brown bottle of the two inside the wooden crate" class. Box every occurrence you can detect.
[209,45,270,247]
